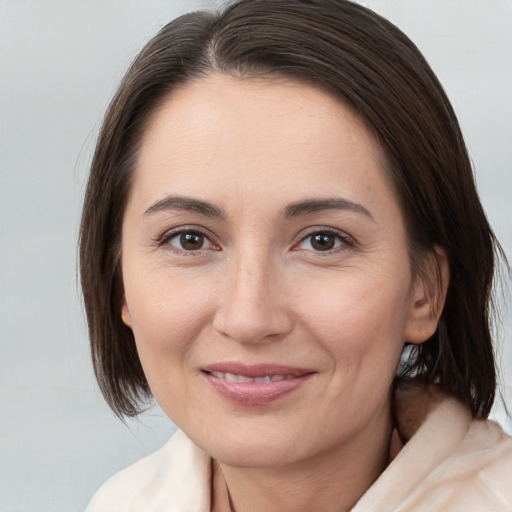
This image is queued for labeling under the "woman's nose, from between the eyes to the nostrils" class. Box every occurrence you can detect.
[213,251,293,344]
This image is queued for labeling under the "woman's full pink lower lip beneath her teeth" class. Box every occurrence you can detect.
[204,373,313,405]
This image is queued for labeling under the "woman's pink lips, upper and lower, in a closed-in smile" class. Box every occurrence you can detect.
[202,362,316,406]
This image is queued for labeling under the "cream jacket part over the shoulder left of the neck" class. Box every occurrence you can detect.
[85,431,211,512]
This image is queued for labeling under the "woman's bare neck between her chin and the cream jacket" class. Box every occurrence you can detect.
[212,412,391,512]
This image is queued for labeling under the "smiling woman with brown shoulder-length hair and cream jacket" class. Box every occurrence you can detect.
[80,0,512,512]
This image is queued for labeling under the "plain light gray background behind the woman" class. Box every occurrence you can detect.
[0,0,512,512]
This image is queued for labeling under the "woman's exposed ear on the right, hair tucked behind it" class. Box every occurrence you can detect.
[404,245,450,344]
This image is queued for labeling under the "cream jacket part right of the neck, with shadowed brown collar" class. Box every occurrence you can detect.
[353,387,512,512]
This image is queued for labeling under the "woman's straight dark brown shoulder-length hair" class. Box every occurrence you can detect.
[80,0,501,417]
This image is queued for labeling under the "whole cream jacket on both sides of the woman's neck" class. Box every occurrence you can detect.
[86,388,512,512]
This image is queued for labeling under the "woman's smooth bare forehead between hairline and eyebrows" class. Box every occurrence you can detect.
[132,75,392,212]
